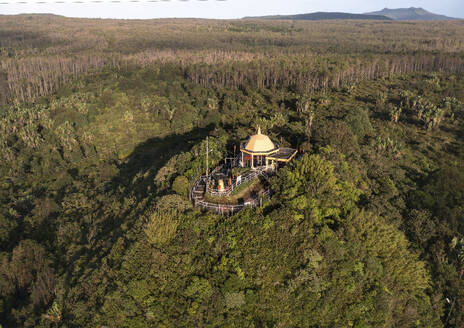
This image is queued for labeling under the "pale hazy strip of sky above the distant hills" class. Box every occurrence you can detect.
[0,0,464,18]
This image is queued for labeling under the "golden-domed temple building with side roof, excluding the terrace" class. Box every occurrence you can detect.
[240,127,297,170]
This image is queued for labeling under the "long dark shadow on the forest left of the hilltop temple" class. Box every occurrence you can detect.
[59,124,214,312]
